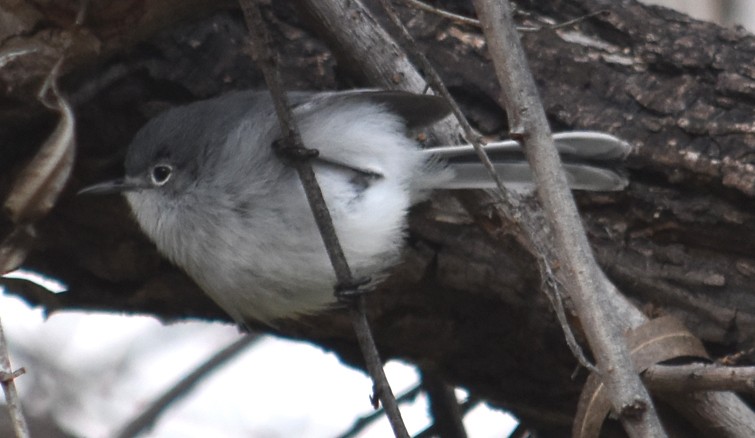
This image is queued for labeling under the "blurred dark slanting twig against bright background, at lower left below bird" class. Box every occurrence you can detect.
[116,334,260,438]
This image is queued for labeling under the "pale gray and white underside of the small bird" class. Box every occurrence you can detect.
[153,166,410,323]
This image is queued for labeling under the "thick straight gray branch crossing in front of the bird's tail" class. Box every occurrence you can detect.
[473,0,666,437]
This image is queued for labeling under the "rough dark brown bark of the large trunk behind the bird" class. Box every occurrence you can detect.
[0,0,755,436]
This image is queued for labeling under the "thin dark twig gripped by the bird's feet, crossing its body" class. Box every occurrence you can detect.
[239,0,409,437]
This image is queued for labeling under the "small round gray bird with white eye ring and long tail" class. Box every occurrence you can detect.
[80,90,629,325]
